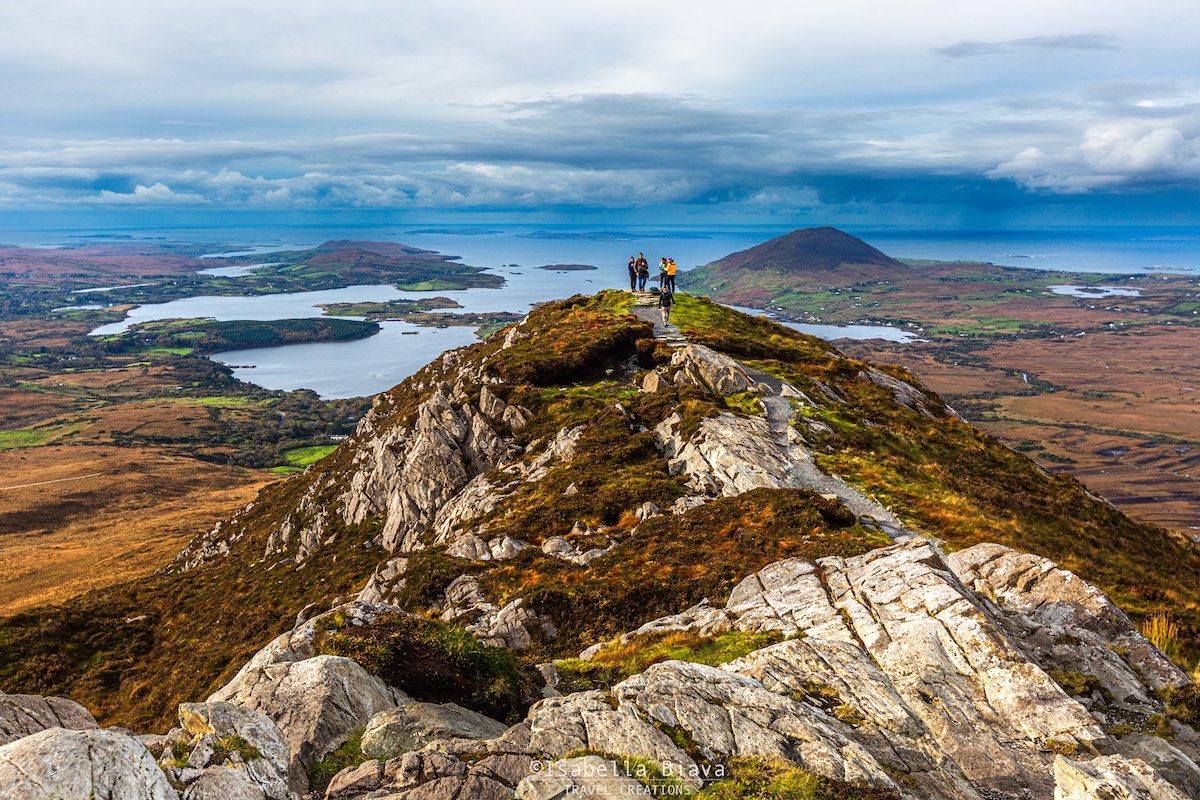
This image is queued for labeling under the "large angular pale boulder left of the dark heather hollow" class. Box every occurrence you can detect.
[209,656,408,769]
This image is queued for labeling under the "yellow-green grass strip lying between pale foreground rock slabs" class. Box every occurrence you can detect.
[554,631,784,693]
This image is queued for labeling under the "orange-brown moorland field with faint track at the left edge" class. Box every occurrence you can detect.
[0,445,274,616]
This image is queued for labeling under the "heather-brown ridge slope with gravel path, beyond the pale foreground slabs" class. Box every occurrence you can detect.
[0,291,1200,743]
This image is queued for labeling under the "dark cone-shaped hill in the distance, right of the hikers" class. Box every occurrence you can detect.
[679,227,912,302]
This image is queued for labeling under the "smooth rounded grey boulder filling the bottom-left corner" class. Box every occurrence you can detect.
[0,728,179,800]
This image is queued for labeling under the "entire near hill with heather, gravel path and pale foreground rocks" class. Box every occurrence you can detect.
[0,291,1200,800]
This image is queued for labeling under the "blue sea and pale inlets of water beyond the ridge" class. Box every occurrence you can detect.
[70,225,1200,397]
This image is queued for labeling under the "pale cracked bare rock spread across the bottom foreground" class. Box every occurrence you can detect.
[0,537,1200,800]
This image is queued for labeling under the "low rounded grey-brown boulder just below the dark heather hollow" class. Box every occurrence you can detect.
[362,703,508,759]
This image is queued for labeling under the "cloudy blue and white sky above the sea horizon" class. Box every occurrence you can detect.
[0,0,1200,229]
